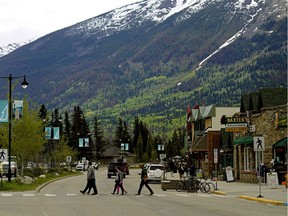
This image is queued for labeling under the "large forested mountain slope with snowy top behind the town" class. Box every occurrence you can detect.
[0,0,287,132]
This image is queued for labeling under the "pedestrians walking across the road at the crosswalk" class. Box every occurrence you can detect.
[80,161,154,195]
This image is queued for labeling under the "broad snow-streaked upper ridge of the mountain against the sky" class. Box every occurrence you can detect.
[66,0,215,38]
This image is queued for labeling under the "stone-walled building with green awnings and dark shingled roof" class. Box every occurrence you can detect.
[233,88,287,183]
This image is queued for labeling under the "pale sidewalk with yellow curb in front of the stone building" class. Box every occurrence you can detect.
[167,172,288,206]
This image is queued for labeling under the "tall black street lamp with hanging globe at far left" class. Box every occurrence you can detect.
[0,74,28,182]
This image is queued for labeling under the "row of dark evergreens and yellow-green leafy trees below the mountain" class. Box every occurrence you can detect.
[0,98,185,175]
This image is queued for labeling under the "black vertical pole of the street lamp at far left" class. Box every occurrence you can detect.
[8,74,12,182]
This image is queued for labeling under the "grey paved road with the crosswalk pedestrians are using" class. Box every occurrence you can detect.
[0,167,287,216]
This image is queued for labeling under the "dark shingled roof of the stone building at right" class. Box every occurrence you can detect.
[240,87,287,112]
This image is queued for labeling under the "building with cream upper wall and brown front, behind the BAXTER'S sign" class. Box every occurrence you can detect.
[187,105,240,177]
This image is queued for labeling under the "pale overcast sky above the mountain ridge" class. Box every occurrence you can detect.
[0,0,140,46]
